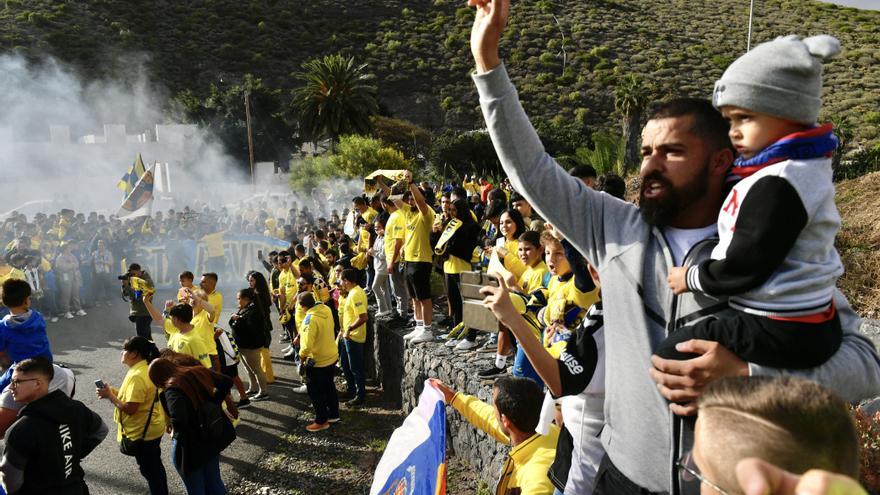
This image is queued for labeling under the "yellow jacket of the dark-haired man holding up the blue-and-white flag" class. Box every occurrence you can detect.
[451,394,559,495]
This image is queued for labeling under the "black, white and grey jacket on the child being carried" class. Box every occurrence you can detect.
[687,158,843,317]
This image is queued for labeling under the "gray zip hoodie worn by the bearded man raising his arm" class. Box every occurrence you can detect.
[474,66,880,493]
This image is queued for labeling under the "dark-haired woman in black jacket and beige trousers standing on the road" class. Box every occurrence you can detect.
[229,287,269,400]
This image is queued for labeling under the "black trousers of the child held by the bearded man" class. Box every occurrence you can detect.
[655,312,843,369]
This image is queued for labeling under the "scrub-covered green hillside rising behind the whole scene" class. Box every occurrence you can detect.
[0,0,880,145]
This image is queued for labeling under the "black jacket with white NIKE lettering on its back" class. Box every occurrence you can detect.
[2,390,108,495]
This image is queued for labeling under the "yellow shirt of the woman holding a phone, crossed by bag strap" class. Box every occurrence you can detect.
[113,359,165,442]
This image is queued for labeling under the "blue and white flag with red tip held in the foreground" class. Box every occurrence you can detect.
[370,380,446,495]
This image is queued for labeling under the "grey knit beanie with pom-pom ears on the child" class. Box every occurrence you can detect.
[712,34,840,124]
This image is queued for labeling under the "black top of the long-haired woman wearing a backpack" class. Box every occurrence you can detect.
[159,374,232,473]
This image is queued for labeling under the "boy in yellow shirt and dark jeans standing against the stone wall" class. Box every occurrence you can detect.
[339,268,368,407]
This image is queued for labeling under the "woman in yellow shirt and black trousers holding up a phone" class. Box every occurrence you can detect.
[95,336,168,495]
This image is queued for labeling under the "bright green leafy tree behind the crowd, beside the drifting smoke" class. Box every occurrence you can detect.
[330,135,412,179]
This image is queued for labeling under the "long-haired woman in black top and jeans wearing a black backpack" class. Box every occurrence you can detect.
[149,358,232,495]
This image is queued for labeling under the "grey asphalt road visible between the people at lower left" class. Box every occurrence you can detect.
[2,290,307,495]
